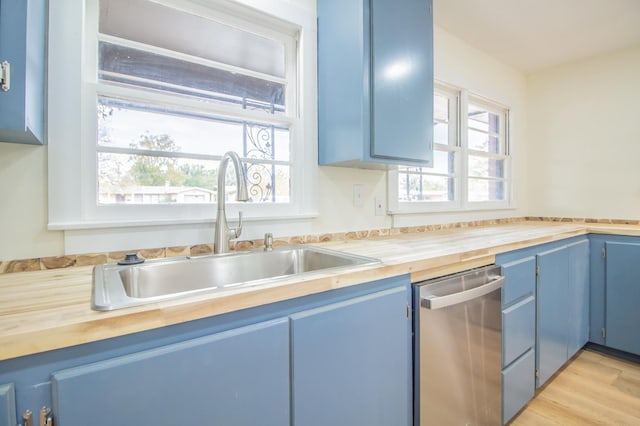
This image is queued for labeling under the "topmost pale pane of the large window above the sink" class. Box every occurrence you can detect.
[100,0,285,77]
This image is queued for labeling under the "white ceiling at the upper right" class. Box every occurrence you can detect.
[433,0,640,73]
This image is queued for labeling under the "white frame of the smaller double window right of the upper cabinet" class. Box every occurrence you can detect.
[388,81,514,216]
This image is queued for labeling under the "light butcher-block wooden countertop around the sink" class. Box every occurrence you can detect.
[0,221,640,360]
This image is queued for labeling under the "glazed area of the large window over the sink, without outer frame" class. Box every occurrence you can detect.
[94,0,296,204]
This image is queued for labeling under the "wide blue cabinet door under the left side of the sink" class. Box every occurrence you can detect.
[52,318,290,426]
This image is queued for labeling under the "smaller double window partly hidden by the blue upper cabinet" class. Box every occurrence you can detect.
[389,83,510,213]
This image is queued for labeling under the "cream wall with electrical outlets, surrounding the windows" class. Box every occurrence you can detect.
[0,5,526,260]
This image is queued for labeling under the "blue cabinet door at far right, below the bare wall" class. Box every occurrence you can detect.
[605,242,640,355]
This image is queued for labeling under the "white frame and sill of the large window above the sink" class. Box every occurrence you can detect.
[48,0,317,251]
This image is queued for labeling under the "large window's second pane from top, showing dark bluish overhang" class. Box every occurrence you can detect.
[99,42,285,114]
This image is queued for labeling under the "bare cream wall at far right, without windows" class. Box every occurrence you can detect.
[527,46,640,219]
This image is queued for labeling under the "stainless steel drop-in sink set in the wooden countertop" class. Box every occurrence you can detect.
[91,245,380,311]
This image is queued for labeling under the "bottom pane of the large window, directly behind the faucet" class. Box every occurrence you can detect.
[97,152,290,204]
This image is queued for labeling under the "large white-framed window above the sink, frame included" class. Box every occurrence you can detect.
[48,0,316,233]
